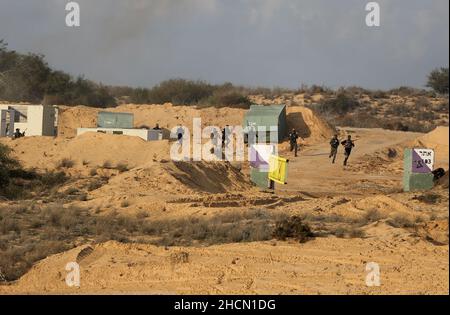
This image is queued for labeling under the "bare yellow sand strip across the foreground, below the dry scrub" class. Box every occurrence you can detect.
[0,238,448,294]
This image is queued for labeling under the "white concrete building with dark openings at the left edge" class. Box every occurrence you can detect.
[0,104,56,136]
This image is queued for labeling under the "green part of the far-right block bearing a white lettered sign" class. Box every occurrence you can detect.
[403,149,434,191]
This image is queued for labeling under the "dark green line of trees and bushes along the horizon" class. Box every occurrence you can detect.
[0,40,448,108]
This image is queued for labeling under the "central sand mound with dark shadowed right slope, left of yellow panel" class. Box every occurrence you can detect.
[92,161,253,205]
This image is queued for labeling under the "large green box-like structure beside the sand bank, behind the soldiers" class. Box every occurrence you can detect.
[242,105,288,142]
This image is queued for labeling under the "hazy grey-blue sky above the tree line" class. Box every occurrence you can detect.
[0,0,449,88]
